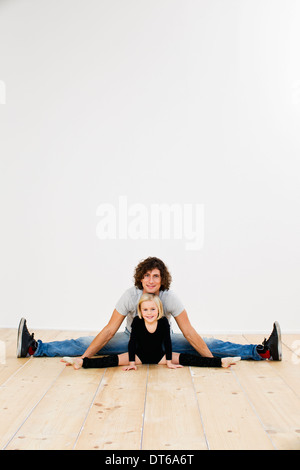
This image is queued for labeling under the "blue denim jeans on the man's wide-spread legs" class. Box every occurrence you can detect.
[34,329,261,361]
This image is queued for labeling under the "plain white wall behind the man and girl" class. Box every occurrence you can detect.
[0,0,300,334]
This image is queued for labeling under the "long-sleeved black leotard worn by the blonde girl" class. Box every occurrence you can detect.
[128,316,172,364]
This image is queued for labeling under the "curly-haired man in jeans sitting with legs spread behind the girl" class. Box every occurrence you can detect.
[17,257,282,361]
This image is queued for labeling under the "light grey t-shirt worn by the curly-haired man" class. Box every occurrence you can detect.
[116,286,184,332]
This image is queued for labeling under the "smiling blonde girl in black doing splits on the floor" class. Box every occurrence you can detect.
[62,294,240,371]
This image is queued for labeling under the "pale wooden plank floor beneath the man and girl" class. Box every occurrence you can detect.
[0,329,300,451]
